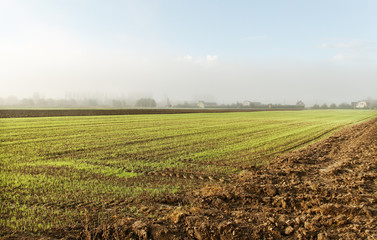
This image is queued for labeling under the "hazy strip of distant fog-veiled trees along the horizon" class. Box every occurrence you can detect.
[0,93,377,109]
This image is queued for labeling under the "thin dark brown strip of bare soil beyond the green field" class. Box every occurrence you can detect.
[0,108,302,118]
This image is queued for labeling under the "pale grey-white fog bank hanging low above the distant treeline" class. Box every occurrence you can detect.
[1,51,377,104]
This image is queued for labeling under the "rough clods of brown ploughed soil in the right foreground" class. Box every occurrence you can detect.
[5,119,377,240]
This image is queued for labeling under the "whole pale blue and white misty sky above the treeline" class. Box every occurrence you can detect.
[0,0,377,104]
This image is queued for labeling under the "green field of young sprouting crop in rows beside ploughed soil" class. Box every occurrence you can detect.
[0,110,377,236]
